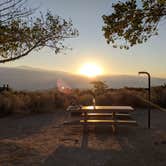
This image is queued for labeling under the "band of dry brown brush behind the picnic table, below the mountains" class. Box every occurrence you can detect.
[0,86,166,116]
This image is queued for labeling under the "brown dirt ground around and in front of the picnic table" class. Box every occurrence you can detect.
[0,109,166,166]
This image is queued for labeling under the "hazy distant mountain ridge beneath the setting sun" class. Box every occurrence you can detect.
[0,66,166,90]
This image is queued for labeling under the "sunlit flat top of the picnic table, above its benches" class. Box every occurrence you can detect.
[67,106,134,112]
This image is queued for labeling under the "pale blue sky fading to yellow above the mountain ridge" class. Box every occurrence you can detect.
[0,0,166,77]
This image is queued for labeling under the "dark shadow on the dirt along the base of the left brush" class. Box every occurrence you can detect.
[0,111,64,140]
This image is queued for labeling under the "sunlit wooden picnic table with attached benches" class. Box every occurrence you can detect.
[65,106,136,132]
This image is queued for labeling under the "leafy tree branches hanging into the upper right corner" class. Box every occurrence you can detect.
[102,0,166,49]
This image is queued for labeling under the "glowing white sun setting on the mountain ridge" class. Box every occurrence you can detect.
[79,63,102,77]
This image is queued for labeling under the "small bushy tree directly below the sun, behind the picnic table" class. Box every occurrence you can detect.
[91,81,108,96]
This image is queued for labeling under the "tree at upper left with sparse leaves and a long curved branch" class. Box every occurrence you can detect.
[0,0,78,63]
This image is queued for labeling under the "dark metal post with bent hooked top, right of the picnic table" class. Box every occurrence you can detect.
[138,71,151,128]
